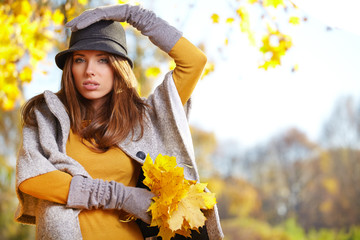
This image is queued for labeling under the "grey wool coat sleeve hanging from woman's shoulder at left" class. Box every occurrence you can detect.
[15,104,88,224]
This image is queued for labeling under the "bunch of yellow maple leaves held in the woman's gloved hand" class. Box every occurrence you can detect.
[143,154,216,240]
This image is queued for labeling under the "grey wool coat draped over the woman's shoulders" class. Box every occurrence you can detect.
[15,72,223,240]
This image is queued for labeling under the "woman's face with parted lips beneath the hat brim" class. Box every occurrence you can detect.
[71,50,114,110]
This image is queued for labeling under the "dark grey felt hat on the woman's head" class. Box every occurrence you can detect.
[55,20,133,69]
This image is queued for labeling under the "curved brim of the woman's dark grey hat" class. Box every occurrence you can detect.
[55,39,133,70]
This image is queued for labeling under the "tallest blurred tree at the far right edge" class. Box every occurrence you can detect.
[299,97,360,229]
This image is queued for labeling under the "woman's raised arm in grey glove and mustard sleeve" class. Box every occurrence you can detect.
[66,4,206,104]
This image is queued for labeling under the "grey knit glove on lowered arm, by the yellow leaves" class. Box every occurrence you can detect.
[66,175,155,224]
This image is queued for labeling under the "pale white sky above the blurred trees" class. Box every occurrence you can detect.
[25,0,360,146]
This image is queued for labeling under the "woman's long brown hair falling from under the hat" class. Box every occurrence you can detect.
[22,55,149,152]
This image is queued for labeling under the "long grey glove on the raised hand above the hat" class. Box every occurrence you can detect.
[66,4,182,53]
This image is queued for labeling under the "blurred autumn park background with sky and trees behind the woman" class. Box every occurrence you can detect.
[0,0,360,240]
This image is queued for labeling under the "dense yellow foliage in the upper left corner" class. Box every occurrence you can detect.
[0,0,64,111]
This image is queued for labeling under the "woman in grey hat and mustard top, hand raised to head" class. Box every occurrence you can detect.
[16,5,223,239]
